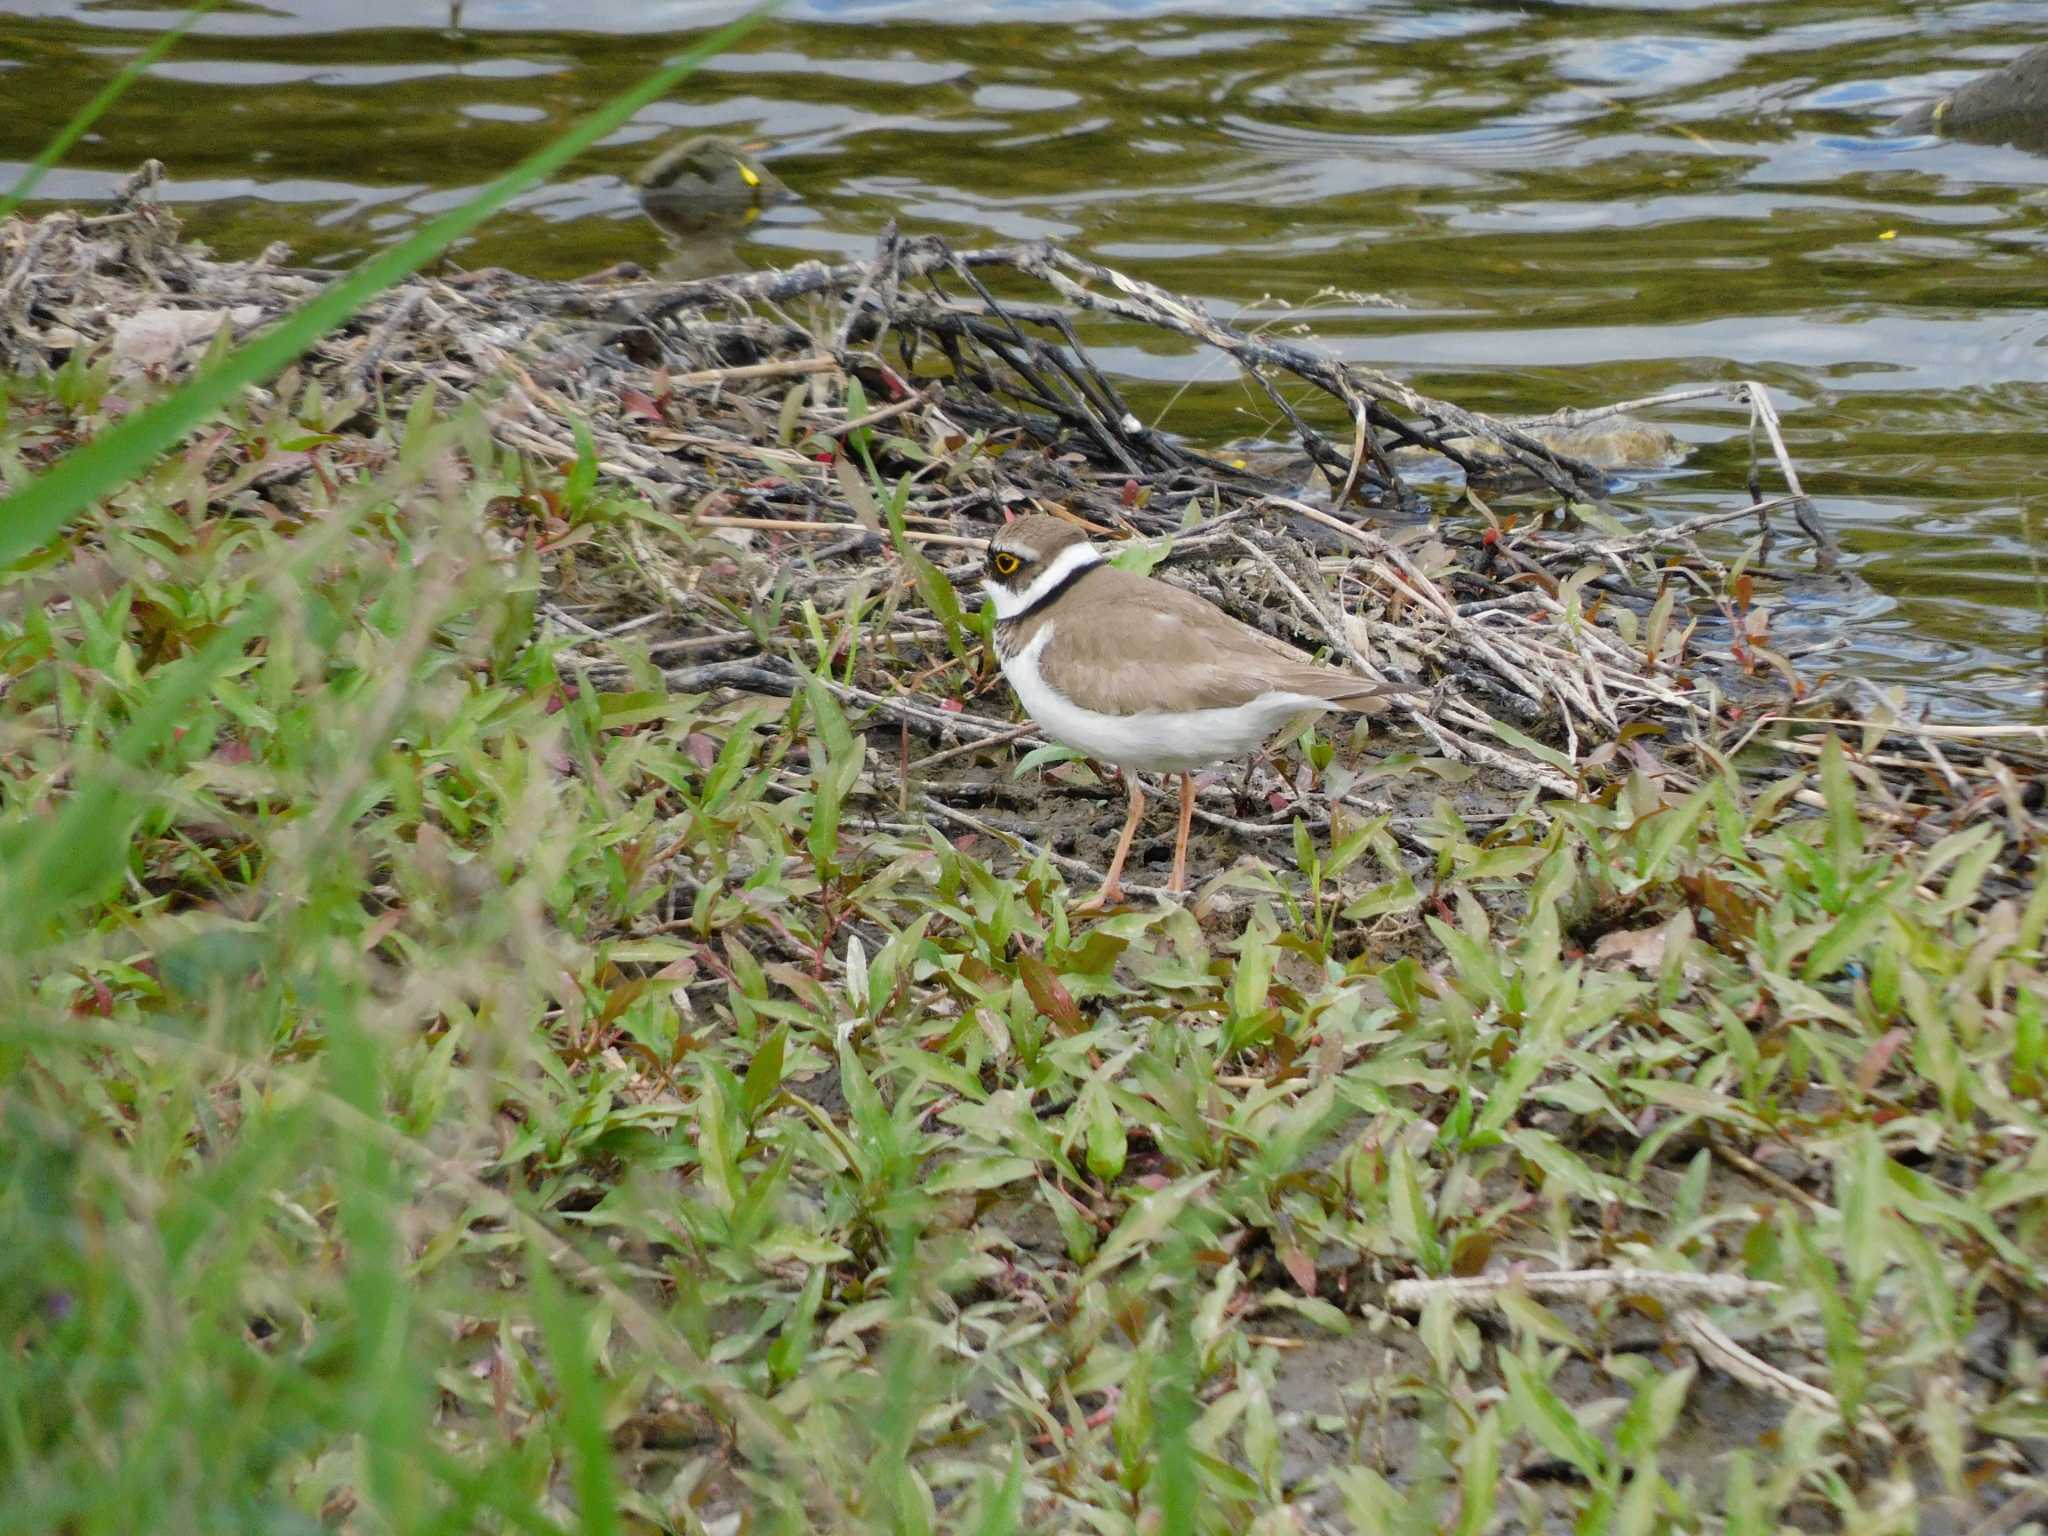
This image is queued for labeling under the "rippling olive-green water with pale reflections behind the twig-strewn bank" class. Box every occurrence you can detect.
[0,0,2048,719]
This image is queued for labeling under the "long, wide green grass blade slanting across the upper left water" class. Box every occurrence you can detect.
[0,0,778,567]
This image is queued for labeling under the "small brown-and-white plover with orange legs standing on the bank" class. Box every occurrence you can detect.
[981,512,1415,909]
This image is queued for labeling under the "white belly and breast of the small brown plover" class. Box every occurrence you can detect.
[1004,625,1331,772]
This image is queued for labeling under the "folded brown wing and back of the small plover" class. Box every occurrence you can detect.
[1038,565,1393,715]
